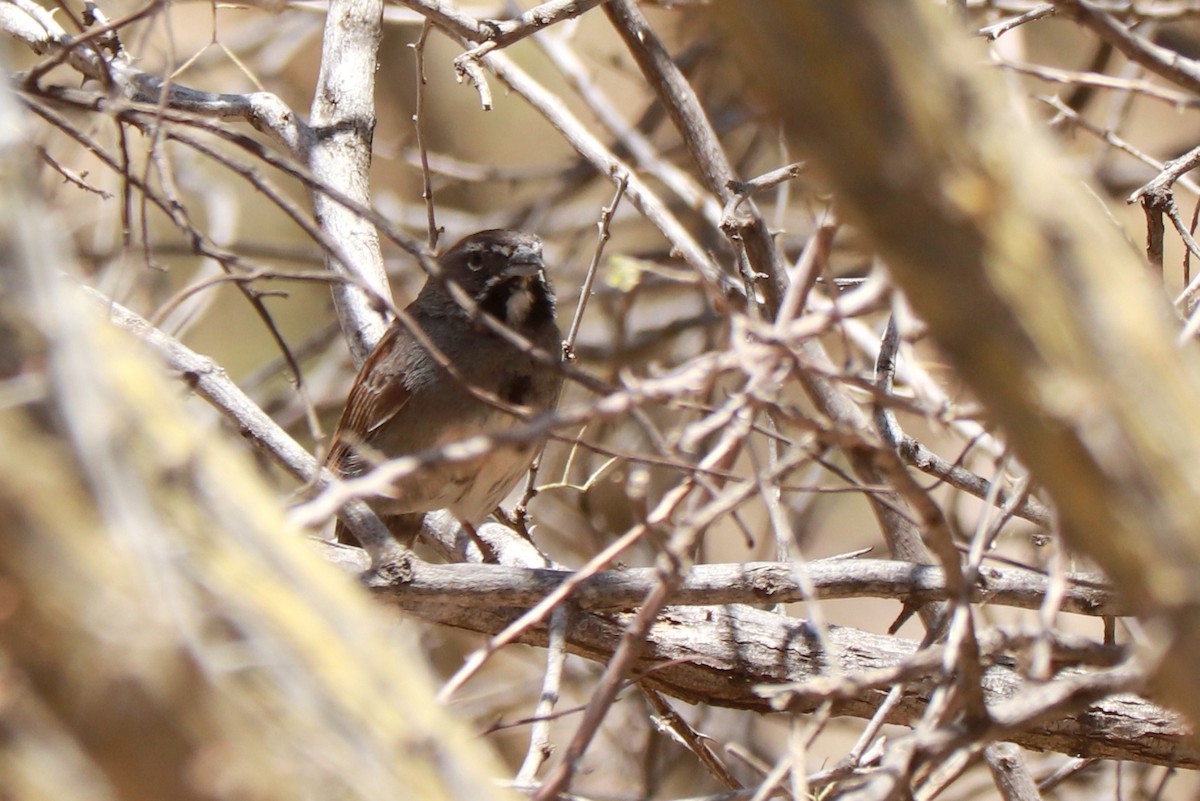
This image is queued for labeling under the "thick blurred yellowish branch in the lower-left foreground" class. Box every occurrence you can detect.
[0,74,504,801]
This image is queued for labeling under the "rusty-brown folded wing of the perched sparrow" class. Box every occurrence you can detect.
[325,325,413,475]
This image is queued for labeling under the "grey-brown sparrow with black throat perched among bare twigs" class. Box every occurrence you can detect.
[325,229,563,544]
